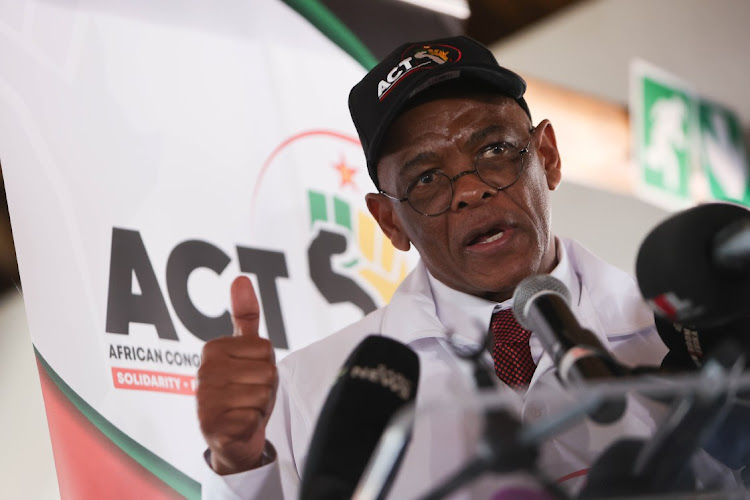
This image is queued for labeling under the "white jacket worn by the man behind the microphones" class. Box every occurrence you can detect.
[203,239,667,499]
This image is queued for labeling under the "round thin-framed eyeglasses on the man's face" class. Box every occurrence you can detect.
[378,127,534,216]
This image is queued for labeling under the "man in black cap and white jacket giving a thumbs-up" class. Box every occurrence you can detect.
[197,37,666,498]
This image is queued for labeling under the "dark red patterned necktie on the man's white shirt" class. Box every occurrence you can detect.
[490,309,536,389]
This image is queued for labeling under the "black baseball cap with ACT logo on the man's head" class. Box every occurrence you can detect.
[349,36,531,189]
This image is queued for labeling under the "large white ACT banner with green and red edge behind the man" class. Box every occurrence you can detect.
[0,0,415,498]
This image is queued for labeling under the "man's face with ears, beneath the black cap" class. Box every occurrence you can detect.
[367,92,560,301]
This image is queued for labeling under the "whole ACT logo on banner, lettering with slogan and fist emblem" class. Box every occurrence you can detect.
[106,130,415,395]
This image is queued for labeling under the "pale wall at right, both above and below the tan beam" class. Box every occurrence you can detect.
[492,0,750,273]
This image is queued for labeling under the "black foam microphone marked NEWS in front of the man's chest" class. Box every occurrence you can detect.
[300,335,419,500]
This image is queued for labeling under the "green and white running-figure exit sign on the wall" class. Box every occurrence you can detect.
[630,61,750,209]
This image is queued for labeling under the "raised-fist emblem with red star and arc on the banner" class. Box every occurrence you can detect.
[250,130,416,349]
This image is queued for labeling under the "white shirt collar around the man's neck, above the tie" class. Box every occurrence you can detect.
[427,237,581,342]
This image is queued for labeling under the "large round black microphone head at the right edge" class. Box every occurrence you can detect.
[636,203,750,328]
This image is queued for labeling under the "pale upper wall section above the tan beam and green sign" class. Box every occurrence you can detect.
[492,0,750,126]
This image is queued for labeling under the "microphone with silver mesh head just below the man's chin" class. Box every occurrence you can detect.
[513,274,626,424]
